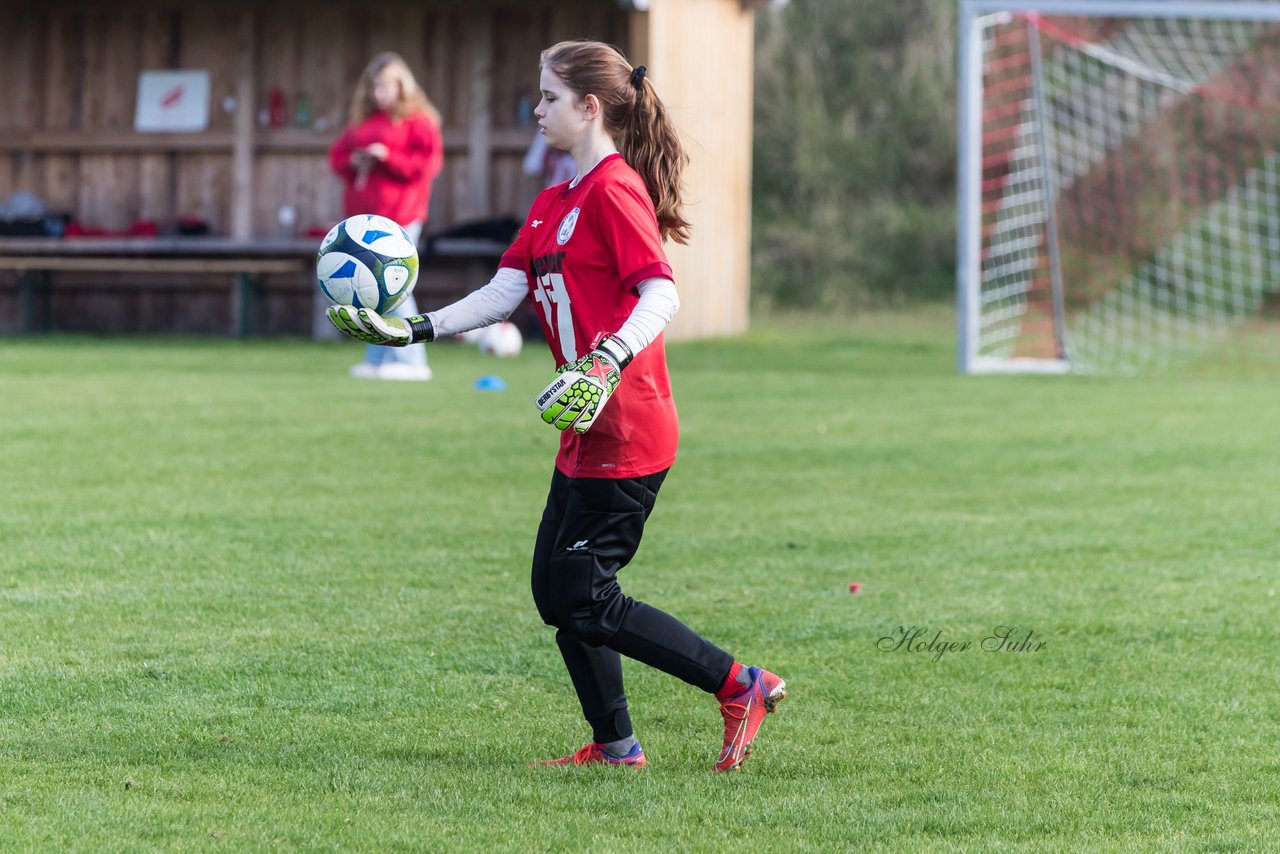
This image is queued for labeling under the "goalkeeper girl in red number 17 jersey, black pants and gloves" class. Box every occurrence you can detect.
[329,41,786,771]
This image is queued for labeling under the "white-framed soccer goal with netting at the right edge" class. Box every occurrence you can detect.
[957,0,1280,373]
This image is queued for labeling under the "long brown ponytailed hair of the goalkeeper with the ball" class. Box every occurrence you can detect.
[539,41,690,243]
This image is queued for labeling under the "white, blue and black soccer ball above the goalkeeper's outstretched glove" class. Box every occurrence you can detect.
[316,214,417,314]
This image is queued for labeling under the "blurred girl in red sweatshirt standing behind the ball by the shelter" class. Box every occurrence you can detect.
[329,52,444,380]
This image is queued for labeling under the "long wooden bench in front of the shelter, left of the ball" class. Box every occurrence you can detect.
[0,237,319,335]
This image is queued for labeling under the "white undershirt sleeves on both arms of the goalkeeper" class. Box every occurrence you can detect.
[426,266,680,353]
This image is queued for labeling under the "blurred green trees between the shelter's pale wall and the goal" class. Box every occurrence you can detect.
[753,0,956,311]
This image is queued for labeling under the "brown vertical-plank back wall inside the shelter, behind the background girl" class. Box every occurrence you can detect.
[0,0,627,240]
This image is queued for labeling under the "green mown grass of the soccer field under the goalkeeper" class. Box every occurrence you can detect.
[0,311,1280,851]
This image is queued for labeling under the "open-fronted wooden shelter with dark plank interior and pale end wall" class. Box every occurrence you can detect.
[0,0,756,337]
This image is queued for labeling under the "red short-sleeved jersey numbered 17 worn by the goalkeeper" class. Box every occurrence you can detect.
[500,154,680,478]
